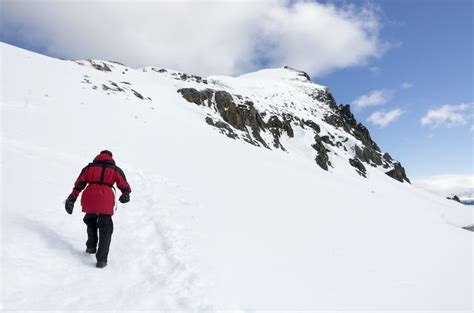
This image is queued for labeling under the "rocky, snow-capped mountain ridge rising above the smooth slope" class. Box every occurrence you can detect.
[77,56,410,182]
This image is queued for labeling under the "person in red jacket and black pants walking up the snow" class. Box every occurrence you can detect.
[65,150,132,268]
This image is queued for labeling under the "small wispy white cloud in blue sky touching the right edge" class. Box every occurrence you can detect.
[420,103,474,128]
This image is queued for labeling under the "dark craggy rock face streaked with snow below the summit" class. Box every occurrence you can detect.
[178,83,410,183]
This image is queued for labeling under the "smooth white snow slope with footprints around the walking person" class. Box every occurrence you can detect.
[1,44,473,311]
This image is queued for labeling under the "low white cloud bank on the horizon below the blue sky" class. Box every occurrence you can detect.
[411,174,474,197]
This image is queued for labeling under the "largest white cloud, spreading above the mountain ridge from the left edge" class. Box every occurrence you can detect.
[0,0,387,75]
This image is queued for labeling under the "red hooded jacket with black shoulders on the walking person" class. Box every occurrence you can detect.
[71,153,132,215]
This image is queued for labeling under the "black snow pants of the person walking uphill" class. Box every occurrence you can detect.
[84,213,114,262]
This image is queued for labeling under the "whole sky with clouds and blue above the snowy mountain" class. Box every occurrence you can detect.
[0,0,474,180]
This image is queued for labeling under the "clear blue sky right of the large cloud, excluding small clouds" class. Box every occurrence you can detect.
[318,0,474,176]
